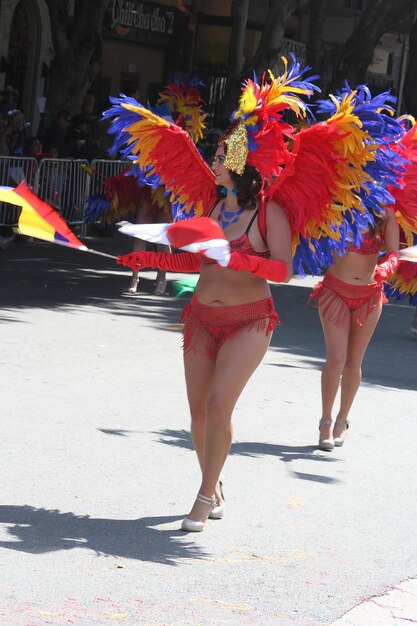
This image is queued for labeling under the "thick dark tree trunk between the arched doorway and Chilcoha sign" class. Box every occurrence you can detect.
[43,0,109,124]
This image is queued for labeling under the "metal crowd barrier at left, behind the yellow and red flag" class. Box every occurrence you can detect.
[0,157,129,236]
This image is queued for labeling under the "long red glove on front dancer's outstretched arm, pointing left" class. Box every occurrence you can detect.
[116,251,201,274]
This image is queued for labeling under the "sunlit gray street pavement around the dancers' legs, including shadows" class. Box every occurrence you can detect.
[0,236,417,626]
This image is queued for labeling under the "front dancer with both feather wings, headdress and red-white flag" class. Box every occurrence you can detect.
[109,59,378,532]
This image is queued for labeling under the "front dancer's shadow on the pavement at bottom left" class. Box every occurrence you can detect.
[0,505,210,566]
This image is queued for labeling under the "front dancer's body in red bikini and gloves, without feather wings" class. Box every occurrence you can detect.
[119,132,292,531]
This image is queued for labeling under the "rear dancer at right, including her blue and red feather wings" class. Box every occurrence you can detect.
[311,107,417,451]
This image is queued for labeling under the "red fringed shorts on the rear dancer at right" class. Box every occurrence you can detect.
[309,273,388,327]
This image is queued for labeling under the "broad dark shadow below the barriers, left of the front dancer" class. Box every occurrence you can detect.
[0,237,180,320]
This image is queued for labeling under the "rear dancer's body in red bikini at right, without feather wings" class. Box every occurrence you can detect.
[311,208,399,451]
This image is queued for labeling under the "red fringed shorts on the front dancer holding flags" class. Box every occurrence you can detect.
[180,295,281,359]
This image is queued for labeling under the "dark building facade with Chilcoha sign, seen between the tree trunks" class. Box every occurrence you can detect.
[0,0,408,133]
